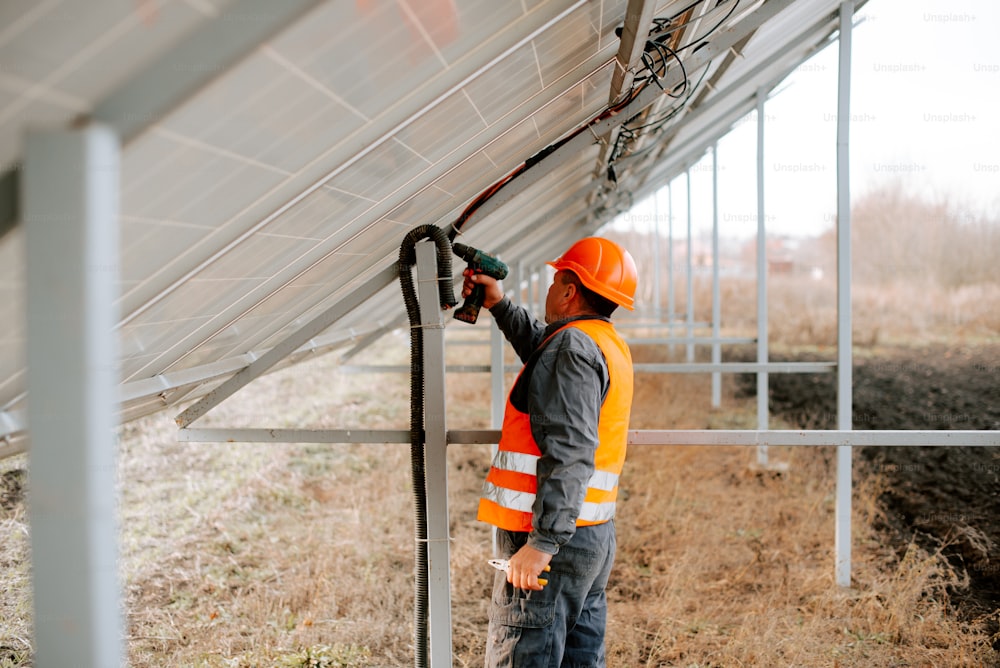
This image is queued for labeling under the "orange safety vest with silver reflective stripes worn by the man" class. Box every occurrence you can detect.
[478,320,632,531]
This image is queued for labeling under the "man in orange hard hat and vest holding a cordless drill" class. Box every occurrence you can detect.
[463,237,636,668]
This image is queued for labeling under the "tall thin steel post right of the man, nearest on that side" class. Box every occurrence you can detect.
[835,0,854,587]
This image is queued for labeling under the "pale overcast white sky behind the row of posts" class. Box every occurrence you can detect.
[617,0,1000,237]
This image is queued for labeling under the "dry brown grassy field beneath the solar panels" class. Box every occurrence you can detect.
[0,316,1000,667]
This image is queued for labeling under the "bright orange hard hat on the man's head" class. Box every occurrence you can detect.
[546,237,637,311]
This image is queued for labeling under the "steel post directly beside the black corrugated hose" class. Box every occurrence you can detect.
[416,241,451,668]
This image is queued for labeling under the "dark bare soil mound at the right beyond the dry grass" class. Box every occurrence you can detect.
[733,345,1000,645]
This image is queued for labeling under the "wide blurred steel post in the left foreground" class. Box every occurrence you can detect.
[21,124,122,668]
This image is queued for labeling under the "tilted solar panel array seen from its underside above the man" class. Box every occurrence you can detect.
[0,0,860,452]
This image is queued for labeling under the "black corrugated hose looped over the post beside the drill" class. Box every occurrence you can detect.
[398,225,458,668]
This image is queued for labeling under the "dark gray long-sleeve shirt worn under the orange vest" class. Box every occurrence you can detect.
[490,297,610,554]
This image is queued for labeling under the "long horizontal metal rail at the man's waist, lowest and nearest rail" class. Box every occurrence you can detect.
[177,428,1000,447]
